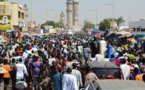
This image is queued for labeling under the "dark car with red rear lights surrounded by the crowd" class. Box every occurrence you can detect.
[87,61,121,79]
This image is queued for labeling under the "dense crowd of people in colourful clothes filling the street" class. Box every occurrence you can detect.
[0,34,145,90]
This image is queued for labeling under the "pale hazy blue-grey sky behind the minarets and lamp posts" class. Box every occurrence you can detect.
[8,0,145,25]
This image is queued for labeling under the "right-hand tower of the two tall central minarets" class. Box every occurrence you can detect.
[73,0,79,27]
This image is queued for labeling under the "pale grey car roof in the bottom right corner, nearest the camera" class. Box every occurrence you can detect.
[81,80,145,90]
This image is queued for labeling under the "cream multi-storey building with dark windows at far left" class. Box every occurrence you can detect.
[0,2,28,30]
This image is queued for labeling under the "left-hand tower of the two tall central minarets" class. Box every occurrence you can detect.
[66,0,73,30]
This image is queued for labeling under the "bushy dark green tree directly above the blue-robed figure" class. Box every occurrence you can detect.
[99,19,110,31]
